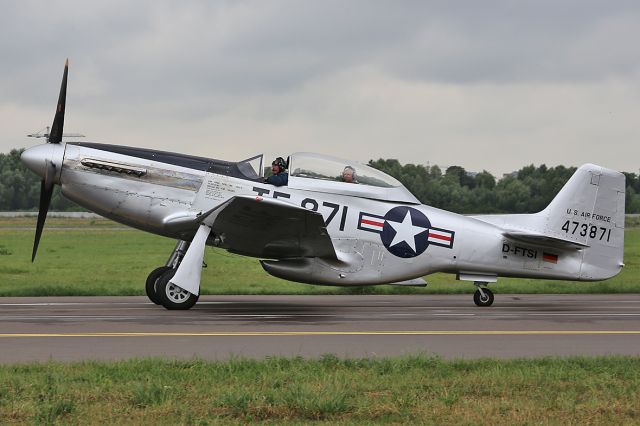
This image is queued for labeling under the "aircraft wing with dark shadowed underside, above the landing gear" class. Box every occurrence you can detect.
[202,196,336,259]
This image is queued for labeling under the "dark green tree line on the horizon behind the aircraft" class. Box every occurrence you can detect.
[0,149,640,214]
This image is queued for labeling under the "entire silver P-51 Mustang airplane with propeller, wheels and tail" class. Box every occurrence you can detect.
[22,60,625,309]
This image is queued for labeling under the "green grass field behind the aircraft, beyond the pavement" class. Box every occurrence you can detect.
[0,218,640,296]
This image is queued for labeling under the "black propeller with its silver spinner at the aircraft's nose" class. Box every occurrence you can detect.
[20,59,69,262]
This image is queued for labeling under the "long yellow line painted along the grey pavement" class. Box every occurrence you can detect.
[0,330,640,338]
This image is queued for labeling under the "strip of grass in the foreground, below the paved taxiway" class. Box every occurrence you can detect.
[0,355,640,424]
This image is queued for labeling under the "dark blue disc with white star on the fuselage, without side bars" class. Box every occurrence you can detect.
[380,206,431,258]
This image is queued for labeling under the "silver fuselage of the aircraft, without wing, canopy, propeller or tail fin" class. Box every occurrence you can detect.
[59,143,580,285]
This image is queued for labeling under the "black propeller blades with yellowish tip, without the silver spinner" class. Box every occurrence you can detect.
[31,59,69,262]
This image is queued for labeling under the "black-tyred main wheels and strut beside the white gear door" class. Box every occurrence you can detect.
[145,240,198,309]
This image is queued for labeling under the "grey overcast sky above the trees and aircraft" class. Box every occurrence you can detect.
[0,0,640,176]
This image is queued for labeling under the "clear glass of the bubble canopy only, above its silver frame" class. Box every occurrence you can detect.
[289,153,402,188]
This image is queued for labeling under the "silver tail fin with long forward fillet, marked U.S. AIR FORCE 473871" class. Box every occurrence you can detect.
[474,164,625,281]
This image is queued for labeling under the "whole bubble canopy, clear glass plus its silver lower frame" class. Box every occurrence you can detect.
[289,152,419,204]
